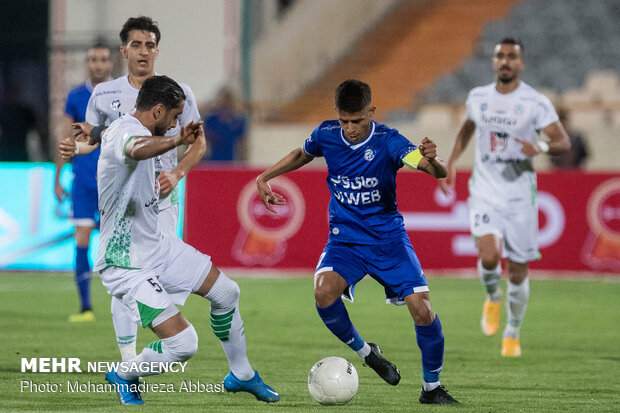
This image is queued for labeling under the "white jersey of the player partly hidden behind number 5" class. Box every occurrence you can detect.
[86,76,200,209]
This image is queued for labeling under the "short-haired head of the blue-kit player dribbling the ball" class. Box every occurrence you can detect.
[335,79,376,143]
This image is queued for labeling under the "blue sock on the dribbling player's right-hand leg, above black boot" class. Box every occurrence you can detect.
[415,316,444,383]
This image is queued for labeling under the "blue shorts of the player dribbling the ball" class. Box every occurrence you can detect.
[314,232,429,305]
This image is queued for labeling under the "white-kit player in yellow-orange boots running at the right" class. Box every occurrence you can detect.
[440,38,570,356]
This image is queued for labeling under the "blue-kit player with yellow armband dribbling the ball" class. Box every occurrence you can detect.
[256,80,457,404]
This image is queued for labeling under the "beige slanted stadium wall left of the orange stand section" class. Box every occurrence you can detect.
[252,0,402,105]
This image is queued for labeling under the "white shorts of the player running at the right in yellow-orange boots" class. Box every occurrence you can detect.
[468,197,540,264]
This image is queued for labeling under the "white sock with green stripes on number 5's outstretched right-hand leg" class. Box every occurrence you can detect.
[205,271,254,381]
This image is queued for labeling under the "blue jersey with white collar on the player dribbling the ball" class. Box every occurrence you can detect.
[304,120,417,245]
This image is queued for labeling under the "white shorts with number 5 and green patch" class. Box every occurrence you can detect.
[100,235,212,327]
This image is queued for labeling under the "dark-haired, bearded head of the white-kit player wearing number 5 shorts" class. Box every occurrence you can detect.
[136,76,185,136]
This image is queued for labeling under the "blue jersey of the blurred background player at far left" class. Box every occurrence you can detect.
[65,81,101,191]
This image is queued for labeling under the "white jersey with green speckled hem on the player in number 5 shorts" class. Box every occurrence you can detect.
[94,114,161,271]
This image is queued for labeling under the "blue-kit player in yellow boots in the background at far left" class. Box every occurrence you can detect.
[54,43,112,322]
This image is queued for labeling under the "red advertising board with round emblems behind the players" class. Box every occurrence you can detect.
[184,167,620,273]
